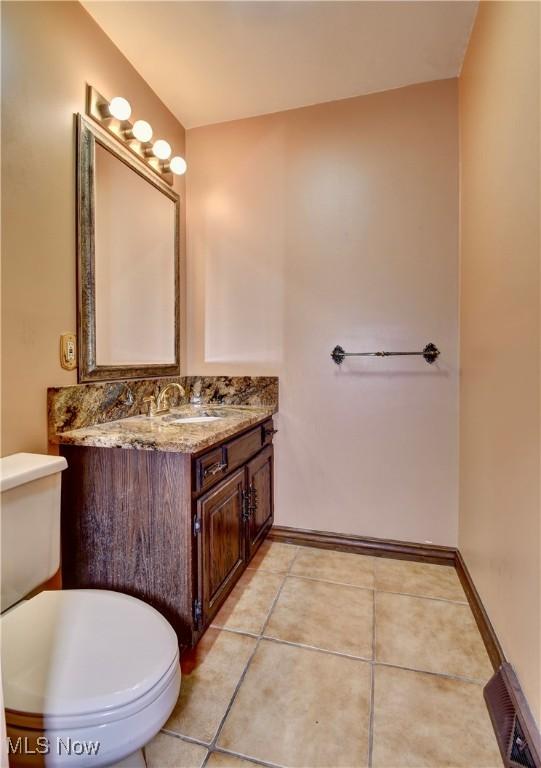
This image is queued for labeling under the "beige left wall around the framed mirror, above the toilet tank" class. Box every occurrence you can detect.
[1,2,184,455]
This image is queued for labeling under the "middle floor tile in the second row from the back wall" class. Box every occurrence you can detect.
[265,577,374,659]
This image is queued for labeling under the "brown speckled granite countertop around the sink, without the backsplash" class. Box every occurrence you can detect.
[52,405,276,453]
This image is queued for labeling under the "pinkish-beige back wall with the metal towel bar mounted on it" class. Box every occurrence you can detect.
[187,80,458,545]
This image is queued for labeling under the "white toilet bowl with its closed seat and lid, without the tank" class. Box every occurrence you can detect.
[1,590,180,768]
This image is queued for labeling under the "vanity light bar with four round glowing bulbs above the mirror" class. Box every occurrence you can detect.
[86,85,186,186]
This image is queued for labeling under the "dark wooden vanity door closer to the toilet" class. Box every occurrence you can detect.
[197,469,246,624]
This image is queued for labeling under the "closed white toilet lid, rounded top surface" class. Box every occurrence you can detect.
[2,589,178,716]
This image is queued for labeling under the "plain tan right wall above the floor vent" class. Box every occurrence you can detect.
[459,2,541,720]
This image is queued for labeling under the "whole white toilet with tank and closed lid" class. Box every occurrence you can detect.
[0,453,180,768]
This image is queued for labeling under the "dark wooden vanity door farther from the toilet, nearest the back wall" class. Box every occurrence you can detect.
[247,445,274,559]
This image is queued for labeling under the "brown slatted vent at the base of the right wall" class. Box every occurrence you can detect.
[484,662,541,768]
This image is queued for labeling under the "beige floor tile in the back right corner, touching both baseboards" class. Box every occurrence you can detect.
[375,557,467,603]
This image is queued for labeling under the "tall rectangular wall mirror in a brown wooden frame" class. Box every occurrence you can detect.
[77,115,180,382]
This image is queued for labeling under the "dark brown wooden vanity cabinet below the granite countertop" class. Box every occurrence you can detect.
[60,420,274,646]
